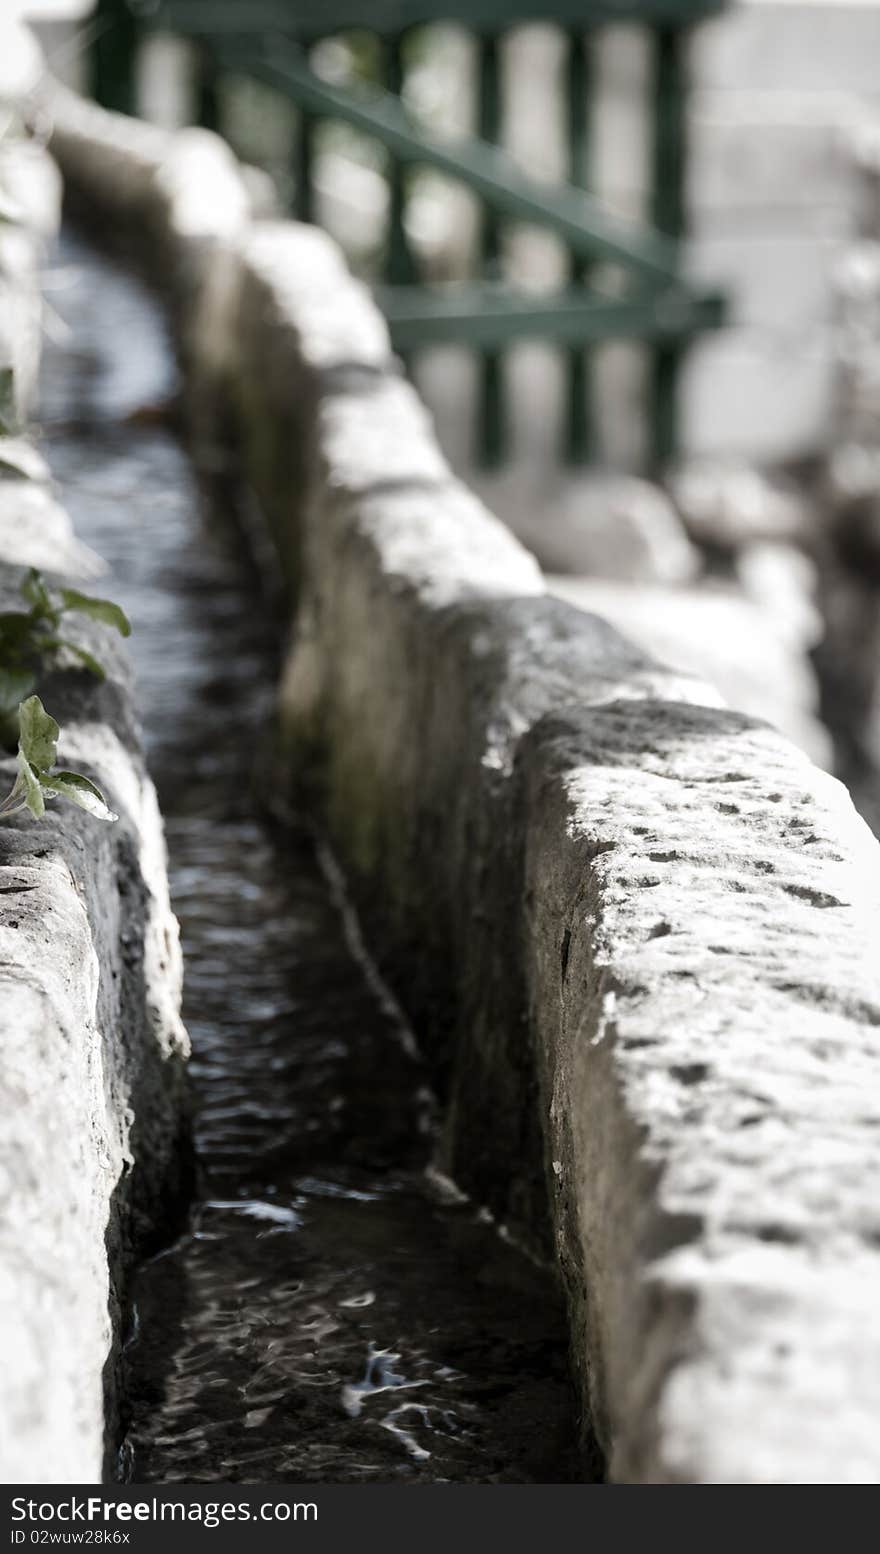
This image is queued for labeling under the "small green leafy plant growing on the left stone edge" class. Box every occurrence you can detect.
[0,567,131,821]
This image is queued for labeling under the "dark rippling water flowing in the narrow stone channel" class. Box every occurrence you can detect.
[42,229,581,1484]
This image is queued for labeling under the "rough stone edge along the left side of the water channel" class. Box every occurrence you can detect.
[0,106,187,1484]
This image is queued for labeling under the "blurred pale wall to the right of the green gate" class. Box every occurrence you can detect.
[686,0,880,458]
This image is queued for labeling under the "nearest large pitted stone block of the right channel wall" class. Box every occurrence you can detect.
[518,701,880,1483]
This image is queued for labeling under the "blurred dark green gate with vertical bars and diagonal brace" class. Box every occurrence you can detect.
[93,0,725,469]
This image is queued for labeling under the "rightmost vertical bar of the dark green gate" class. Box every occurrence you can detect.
[650,26,687,471]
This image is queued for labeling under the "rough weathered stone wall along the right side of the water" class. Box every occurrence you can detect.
[41,81,880,1483]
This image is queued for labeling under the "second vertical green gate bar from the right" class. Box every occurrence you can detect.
[564,31,595,463]
